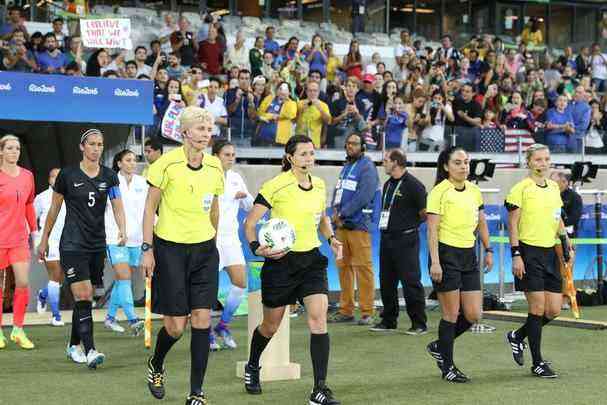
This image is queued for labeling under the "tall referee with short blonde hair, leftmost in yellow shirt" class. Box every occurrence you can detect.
[141,106,224,405]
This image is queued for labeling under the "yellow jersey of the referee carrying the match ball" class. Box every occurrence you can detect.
[259,170,327,252]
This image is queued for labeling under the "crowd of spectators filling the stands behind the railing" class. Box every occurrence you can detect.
[0,4,607,153]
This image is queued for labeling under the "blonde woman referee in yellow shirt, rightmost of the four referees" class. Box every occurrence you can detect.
[506,144,571,378]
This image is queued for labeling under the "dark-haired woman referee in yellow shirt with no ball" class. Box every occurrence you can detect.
[426,147,493,383]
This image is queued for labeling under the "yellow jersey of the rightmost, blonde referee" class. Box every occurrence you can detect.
[506,177,563,247]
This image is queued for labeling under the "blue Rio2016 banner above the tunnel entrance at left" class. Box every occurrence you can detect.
[0,72,154,125]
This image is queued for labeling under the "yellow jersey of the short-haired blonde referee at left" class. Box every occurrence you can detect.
[147,146,224,243]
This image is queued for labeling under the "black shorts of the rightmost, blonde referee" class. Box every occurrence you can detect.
[514,242,563,293]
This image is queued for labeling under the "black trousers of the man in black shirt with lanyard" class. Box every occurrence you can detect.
[379,231,427,327]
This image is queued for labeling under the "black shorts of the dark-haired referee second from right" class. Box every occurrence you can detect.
[428,242,481,292]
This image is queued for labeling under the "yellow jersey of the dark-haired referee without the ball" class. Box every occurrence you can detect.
[427,180,483,248]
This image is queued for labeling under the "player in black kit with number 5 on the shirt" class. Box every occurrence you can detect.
[38,129,126,369]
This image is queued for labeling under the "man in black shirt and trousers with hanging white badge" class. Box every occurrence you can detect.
[371,149,428,335]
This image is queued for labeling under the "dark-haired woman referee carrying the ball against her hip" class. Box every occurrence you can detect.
[245,135,341,405]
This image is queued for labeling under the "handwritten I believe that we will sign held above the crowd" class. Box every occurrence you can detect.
[80,18,133,49]
